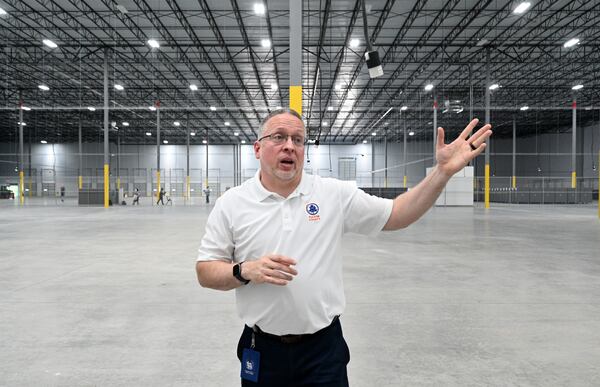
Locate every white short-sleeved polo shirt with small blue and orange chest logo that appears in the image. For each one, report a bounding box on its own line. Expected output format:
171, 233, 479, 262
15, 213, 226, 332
198, 171, 393, 335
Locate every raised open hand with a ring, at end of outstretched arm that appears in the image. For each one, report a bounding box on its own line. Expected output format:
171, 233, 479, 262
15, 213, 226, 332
436, 118, 492, 177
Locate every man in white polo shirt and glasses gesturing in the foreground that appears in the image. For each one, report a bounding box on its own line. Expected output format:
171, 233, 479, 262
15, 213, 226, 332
196, 110, 492, 387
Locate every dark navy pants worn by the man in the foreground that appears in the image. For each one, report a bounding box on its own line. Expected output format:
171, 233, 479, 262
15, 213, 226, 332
237, 320, 350, 387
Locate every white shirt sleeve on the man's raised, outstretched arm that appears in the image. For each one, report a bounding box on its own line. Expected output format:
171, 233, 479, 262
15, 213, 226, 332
340, 181, 394, 236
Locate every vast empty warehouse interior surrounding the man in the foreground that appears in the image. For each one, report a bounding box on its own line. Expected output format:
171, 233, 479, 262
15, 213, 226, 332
0, 0, 600, 387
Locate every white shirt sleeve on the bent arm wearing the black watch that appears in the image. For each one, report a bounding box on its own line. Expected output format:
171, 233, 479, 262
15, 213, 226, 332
197, 198, 234, 262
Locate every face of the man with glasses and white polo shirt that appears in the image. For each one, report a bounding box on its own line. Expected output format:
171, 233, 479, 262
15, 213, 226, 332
254, 113, 305, 183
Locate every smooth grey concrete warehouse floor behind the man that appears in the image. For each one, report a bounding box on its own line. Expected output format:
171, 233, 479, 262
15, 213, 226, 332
0, 201, 600, 387
